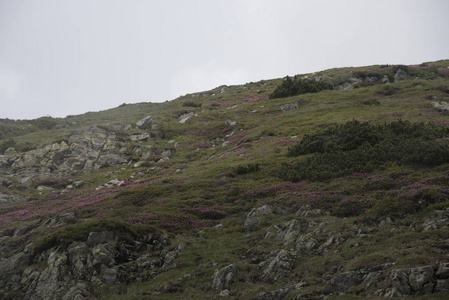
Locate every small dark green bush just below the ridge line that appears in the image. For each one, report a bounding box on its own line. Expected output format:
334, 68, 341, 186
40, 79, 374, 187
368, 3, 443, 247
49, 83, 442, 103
269, 76, 333, 99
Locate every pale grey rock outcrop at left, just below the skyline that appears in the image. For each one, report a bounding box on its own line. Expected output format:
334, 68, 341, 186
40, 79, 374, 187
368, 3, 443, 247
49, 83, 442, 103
0, 116, 162, 186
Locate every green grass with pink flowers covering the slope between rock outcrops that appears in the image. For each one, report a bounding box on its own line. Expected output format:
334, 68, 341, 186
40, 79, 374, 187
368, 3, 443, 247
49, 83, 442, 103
0, 60, 449, 299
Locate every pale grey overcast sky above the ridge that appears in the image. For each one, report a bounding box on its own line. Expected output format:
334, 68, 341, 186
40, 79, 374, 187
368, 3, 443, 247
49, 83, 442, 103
0, 0, 449, 119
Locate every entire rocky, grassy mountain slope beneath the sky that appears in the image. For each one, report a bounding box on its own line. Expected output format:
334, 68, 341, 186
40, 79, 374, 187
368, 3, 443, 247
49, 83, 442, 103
0, 60, 449, 299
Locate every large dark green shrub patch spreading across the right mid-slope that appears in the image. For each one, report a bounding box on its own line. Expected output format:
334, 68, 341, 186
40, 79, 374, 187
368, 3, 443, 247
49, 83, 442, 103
279, 120, 449, 182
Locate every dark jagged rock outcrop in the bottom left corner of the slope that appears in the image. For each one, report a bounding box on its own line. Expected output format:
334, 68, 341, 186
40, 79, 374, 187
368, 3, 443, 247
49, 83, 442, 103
0, 216, 185, 300
